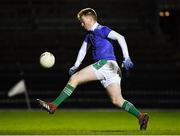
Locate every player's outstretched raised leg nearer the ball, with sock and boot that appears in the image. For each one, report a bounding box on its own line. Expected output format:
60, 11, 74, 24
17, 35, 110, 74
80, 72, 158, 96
37, 65, 98, 114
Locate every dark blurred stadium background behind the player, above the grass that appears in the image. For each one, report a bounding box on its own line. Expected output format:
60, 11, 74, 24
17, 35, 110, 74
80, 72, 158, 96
0, 0, 180, 109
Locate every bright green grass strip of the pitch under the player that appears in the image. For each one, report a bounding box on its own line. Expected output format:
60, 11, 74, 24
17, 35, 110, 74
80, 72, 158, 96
0, 110, 180, 135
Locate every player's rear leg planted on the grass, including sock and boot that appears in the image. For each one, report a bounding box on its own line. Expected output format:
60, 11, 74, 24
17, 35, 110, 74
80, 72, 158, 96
106, 83, 149, 130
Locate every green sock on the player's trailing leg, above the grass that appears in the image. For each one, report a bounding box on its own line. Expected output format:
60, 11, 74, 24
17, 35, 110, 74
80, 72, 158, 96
122, 101, 140, 118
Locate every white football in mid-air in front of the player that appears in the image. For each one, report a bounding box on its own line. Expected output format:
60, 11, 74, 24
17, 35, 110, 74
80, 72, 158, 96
40, 52, 55, 68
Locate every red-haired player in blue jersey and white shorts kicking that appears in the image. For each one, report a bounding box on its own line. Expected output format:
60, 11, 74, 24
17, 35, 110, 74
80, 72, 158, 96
37, 8, 149, 130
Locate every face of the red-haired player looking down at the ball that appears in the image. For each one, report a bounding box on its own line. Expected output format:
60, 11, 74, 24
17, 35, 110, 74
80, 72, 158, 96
80, 15, 94, 31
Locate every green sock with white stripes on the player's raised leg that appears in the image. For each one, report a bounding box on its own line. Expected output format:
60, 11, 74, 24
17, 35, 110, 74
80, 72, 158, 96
52, 84, 75, 106
